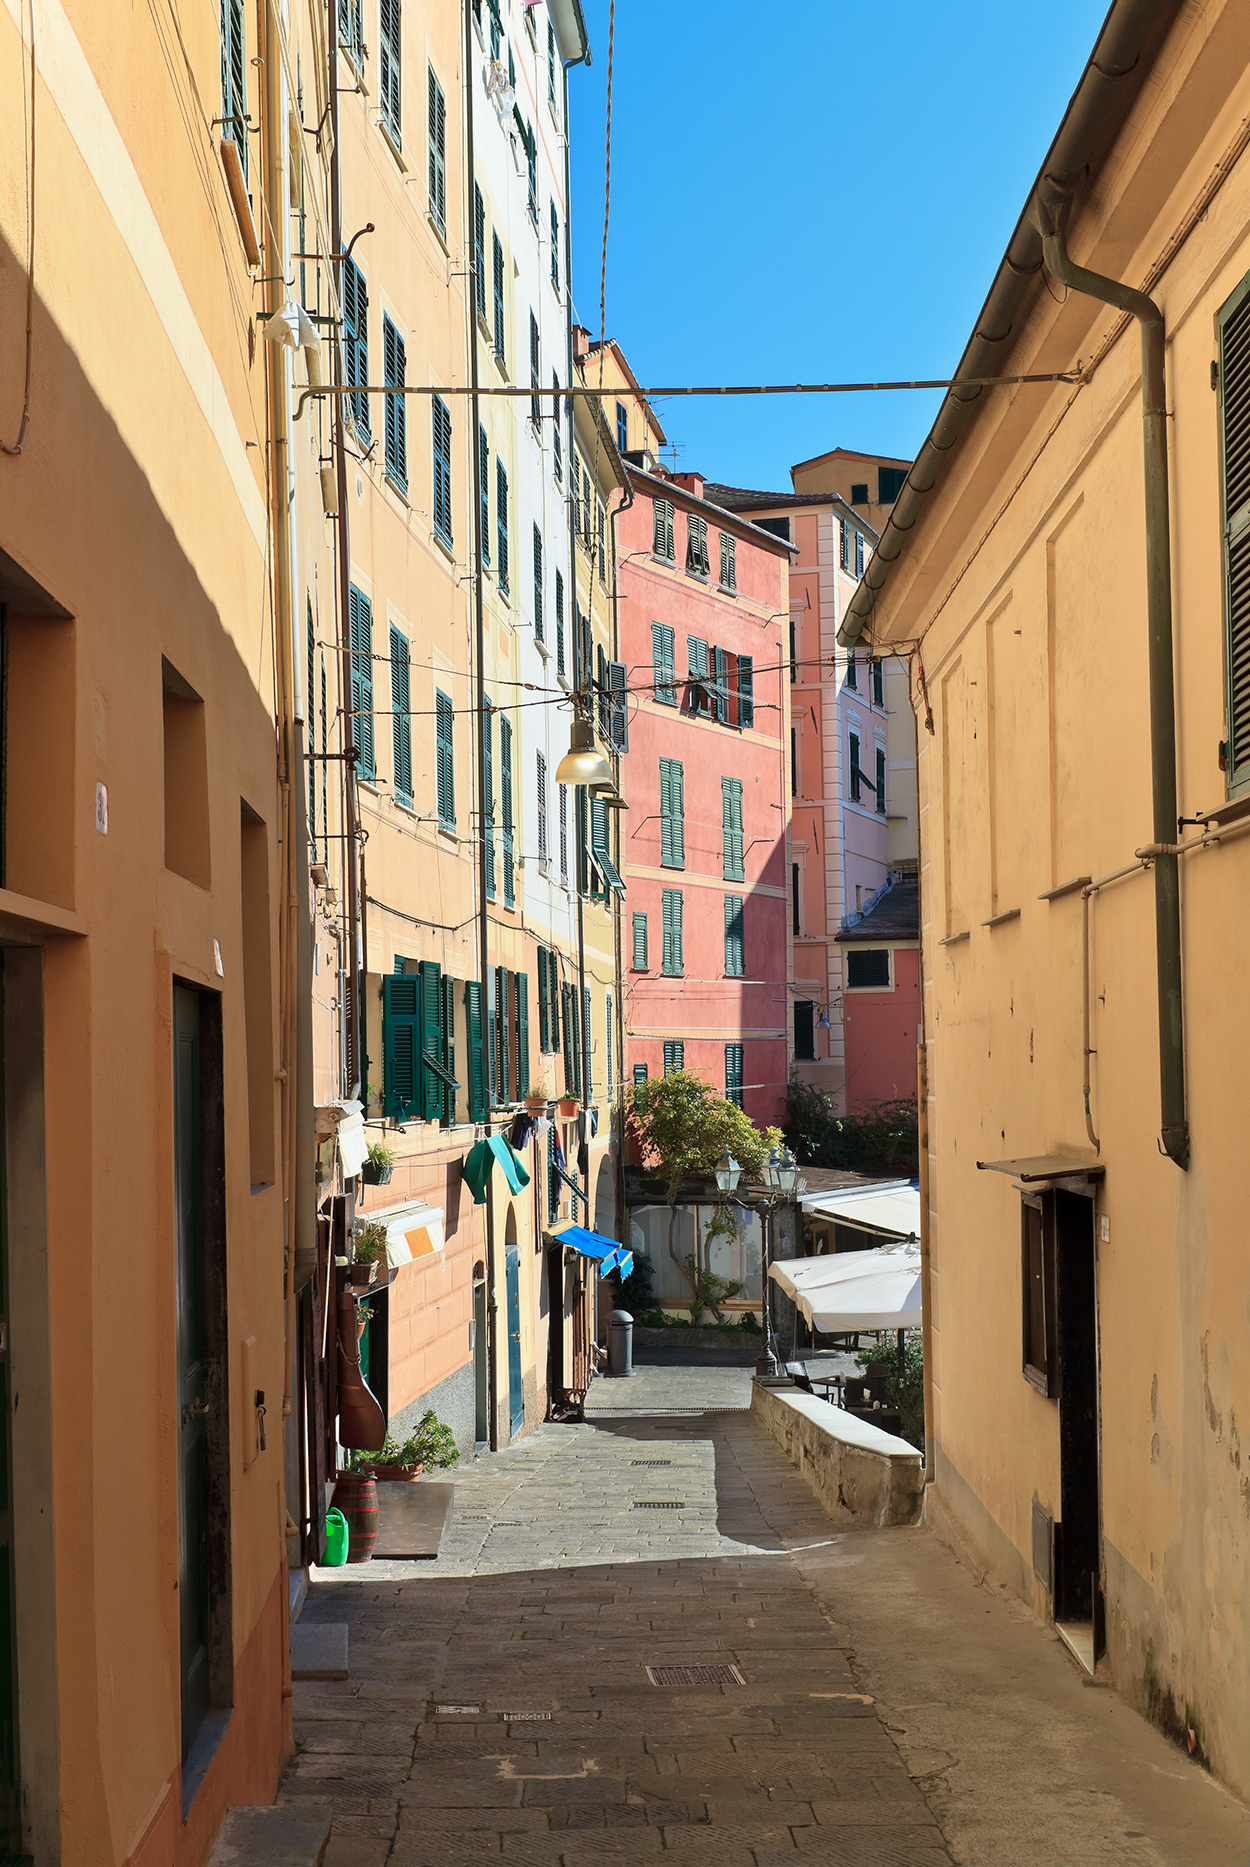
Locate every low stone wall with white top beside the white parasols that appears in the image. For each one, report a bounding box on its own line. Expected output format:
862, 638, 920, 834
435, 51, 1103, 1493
750, 1382, 924, 1529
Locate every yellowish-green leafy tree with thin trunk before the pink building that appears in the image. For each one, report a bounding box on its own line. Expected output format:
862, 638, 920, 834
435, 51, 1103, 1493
629, 1070, 782, 1301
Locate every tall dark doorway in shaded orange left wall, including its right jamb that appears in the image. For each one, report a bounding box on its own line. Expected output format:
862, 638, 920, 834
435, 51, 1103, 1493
174, 984, 233, 1787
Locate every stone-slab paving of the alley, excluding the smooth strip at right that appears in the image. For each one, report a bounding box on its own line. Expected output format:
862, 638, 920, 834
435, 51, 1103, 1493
280, 1369, 951, 1867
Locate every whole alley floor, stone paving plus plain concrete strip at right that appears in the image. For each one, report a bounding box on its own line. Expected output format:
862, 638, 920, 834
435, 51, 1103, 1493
278, 1367, 1244, 1867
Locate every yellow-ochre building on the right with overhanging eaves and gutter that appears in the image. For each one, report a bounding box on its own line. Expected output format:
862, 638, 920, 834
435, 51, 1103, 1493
840, 4, 1250, 1794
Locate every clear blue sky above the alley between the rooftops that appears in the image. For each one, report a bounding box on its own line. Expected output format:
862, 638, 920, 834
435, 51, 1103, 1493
569, 0, 1106, 487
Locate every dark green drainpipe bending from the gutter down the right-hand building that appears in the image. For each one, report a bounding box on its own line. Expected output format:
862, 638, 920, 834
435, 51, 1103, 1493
1035, 187, 1188, 1171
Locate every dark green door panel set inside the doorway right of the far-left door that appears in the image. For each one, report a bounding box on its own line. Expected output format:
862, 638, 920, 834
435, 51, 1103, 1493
174, 986, 209, 1762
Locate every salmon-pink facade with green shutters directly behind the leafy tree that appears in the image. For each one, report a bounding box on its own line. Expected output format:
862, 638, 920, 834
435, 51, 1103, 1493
616, 469, 791, 1126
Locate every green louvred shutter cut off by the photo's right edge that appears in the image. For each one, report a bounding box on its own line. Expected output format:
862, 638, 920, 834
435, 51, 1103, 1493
1218, 276, 1250, 797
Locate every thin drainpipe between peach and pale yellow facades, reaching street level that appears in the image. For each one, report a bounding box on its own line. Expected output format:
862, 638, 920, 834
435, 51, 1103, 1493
463, 0, 500, 1453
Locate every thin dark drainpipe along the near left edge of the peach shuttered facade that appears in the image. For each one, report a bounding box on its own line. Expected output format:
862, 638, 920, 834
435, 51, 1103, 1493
326, 6, 362, 1098
